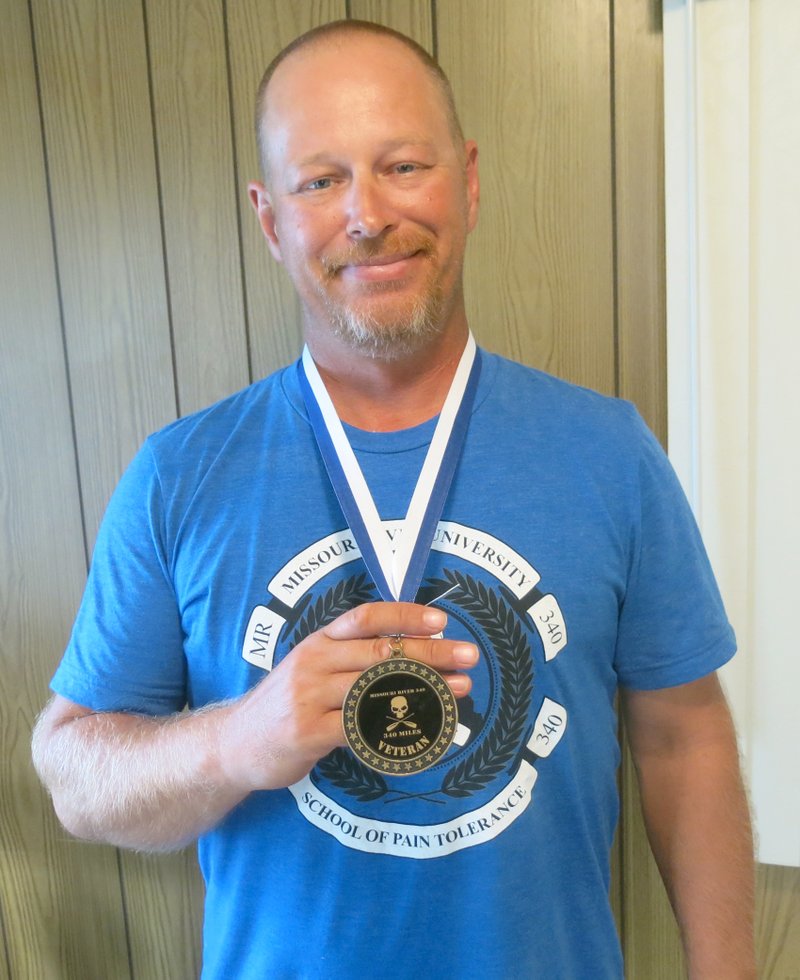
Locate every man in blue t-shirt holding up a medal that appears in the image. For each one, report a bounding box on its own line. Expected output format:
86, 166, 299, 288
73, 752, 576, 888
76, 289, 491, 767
34, 22, 754, 978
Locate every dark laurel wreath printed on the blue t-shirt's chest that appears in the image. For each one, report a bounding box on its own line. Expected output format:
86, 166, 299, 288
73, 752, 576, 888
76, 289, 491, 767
304, 571, 533, 802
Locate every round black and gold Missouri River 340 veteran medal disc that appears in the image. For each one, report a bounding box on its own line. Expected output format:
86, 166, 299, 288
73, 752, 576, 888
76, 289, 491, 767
343, 637, 458, 776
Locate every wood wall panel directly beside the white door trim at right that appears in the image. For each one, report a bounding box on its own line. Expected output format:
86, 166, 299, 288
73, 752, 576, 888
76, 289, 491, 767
612, 0, 685, 980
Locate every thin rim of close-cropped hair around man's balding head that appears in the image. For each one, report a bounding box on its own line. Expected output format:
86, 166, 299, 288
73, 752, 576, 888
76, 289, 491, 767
255, 20, 464, 181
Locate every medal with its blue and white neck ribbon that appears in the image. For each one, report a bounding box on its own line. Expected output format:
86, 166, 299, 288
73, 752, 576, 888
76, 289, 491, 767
299, 334, 480, 776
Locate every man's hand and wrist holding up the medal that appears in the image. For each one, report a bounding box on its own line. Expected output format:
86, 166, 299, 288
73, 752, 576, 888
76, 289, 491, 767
219, 602, 478, 793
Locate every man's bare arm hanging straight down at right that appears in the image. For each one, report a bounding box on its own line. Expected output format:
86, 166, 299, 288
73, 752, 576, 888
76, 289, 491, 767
622, 674, 756, 980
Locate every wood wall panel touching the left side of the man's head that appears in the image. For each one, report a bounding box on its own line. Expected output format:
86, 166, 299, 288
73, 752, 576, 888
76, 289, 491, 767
228, 0, 345, 378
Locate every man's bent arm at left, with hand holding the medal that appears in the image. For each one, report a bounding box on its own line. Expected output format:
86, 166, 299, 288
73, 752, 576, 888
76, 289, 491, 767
33, 602, 478, 850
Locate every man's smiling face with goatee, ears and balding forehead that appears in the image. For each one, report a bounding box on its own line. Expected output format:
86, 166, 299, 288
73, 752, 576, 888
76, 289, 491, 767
250, 34, 478, 372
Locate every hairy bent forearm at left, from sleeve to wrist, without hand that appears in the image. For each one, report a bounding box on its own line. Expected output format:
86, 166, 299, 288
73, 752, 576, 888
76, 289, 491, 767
33, 707, 245, 851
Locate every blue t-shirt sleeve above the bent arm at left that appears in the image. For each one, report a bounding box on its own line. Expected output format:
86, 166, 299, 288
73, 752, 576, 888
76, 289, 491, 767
50, 443, 186, 714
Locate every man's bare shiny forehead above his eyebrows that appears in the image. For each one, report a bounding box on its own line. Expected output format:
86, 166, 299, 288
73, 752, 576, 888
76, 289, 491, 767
264, 35, 450, 162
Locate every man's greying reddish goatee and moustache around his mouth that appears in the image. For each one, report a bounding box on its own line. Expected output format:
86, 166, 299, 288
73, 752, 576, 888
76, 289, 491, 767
320, 235, 445, 361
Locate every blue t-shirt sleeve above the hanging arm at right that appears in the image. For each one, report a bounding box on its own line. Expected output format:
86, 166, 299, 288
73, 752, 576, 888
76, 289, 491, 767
615, 413, 736, 690
